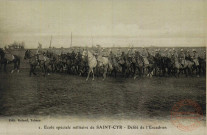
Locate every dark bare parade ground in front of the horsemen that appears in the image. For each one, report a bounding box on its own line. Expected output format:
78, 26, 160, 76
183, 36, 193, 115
0, 66, 206, 119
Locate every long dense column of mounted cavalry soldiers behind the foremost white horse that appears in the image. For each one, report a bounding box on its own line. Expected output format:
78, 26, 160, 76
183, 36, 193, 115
1, 46, 206, 78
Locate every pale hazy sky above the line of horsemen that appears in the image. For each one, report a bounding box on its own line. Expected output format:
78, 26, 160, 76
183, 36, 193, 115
0, 0, 207, 48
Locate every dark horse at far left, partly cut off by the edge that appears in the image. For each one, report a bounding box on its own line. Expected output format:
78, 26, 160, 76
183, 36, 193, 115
0, 49, 20, 73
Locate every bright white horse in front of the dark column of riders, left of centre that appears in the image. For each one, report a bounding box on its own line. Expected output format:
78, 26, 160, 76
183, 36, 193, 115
82, 51, 112, 81
